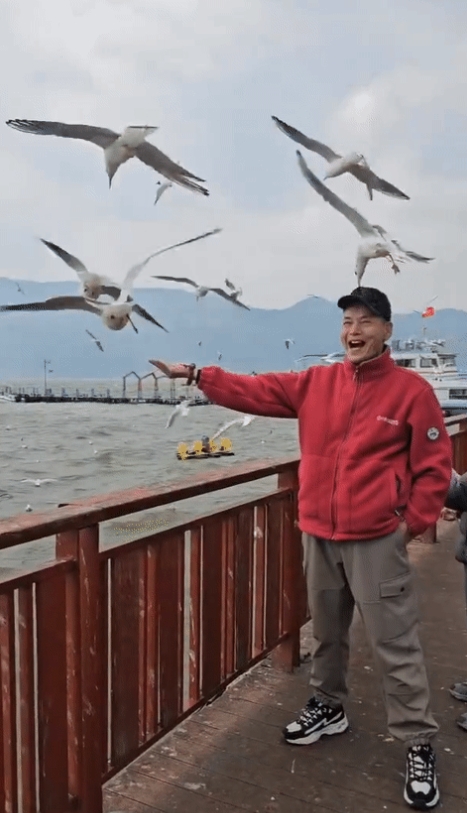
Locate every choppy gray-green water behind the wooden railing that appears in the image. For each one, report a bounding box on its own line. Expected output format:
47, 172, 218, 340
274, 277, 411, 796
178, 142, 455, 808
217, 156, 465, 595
0, 382, 298, 568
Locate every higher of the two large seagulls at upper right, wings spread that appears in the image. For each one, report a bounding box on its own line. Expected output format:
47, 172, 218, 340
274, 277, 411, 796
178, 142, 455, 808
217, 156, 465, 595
271, 116, 410, 200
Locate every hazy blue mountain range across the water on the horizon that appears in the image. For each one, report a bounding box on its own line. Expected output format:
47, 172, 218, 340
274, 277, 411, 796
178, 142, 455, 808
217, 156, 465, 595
0, 277, 467, 382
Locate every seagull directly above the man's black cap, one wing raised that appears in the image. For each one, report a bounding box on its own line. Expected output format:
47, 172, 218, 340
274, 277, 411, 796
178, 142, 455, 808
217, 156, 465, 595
297, 150, 434, 285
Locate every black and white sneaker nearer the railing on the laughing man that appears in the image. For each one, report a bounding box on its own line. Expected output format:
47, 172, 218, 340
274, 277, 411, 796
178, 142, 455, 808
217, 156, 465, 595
284, 697, 349, 745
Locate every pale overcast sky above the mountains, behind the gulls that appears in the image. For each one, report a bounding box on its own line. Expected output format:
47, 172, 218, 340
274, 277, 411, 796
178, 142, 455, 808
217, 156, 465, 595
0, 0, 467, 312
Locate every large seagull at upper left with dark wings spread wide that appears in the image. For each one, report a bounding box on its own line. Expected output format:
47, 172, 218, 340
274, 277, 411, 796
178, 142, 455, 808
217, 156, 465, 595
6, 119, 209, 195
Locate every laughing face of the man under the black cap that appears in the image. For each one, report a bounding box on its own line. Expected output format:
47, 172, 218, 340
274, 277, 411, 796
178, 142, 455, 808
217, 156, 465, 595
341, 305, 392, 364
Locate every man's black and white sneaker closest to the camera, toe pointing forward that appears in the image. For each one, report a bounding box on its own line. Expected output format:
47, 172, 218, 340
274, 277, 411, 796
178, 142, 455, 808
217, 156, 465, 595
404, 744, 439, 810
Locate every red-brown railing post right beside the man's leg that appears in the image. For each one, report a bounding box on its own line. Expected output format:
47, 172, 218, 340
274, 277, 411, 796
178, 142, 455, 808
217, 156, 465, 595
271, 465, 304, 672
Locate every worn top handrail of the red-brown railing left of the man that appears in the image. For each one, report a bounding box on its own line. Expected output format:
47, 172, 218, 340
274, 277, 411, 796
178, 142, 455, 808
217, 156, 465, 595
0, 455, 299, 550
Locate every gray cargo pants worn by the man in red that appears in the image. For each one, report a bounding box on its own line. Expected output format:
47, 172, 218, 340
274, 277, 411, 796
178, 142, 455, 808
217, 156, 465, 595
303, 530, 439, 745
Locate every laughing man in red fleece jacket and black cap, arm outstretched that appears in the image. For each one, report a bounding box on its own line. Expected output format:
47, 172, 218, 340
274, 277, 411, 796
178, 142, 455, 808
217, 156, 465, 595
153, 287, 451, 810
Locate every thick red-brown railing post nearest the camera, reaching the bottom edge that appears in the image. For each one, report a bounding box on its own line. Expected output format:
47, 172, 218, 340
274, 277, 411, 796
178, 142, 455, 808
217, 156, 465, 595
57, 525, 104, 813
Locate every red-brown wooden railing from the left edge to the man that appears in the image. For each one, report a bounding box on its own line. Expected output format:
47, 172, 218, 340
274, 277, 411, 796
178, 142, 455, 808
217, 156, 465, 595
0, 458, 306, 813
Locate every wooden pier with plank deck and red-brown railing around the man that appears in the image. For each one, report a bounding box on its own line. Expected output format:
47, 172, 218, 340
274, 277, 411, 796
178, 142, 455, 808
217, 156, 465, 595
0, 416, 467, 813
